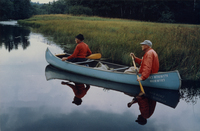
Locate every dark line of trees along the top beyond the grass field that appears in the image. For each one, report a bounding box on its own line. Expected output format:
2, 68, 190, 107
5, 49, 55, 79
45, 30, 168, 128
0, 0, 200, 24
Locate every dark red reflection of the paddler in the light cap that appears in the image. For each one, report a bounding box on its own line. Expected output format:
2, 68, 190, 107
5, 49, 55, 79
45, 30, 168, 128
127, 94, 156, 125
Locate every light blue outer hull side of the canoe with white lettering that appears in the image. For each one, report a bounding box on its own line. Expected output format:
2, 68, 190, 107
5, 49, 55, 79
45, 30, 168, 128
46, 48, 181, 90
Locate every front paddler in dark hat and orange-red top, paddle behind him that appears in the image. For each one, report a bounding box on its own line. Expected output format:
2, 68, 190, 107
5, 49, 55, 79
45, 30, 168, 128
62, 34, 92, 62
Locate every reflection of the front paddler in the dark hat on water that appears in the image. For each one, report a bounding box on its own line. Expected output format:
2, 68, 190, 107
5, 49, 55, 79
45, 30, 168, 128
61, 81, 90, 106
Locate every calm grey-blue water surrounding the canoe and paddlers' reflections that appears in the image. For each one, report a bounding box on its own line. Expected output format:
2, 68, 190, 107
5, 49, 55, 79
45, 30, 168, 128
0, 22, 200, 131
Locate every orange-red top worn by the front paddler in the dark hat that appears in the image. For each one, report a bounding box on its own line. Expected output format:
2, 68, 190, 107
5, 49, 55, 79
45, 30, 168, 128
68, 42, 92, 59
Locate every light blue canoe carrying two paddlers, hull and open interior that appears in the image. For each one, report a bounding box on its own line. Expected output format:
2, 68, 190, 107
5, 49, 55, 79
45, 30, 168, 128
45, 48, 181, 90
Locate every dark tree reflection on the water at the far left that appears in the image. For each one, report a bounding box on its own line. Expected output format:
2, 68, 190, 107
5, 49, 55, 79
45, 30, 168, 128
0, 23, 30, 52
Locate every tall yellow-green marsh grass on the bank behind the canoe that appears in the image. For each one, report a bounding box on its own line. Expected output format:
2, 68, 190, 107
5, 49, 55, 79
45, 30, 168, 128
18, 15, 200, 80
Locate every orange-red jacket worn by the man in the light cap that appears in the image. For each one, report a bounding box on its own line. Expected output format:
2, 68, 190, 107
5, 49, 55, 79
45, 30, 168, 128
135, 48, 159, 80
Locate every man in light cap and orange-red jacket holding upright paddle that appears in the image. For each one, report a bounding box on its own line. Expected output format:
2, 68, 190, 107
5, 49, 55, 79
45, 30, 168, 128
130, 40, 159, 81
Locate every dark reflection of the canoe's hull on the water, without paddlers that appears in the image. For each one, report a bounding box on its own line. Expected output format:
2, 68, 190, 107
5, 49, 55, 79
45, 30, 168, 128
45, 65, 180, 108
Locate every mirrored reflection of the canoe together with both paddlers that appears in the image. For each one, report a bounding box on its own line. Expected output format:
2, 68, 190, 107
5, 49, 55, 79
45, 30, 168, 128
45, 65, 179, 125
